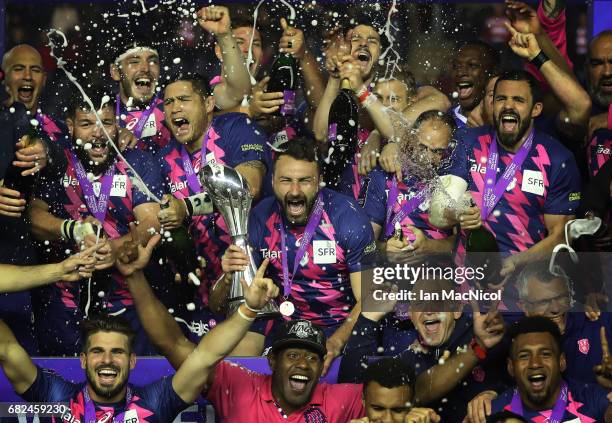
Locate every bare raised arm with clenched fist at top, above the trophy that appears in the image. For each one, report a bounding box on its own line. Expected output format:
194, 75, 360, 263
198, 6, 251, 110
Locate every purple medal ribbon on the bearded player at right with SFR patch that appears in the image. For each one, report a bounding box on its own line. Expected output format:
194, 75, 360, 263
481, 129, 534, 221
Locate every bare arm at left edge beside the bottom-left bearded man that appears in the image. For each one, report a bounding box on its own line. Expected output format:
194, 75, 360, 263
0, 320, 38, 395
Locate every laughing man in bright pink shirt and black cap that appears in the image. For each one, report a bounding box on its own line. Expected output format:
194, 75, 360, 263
120, 237, 365, 423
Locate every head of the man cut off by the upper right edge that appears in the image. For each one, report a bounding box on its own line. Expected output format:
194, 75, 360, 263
587, 30, 612, 108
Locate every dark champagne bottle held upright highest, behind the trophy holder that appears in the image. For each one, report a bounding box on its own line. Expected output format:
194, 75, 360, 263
267, 35, 299, 116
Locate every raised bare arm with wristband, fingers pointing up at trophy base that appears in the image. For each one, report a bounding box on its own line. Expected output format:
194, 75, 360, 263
172, 259, 278, 402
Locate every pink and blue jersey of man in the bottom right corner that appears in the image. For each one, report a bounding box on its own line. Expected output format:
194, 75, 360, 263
491, 380, 609, 423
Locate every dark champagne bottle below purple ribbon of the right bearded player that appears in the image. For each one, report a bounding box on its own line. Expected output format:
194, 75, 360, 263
465, 225, 502, 288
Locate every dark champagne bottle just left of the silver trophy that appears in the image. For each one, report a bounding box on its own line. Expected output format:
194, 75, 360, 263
161, 202, 200, 309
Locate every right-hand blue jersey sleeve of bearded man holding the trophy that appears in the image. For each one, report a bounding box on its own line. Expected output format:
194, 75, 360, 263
338, 200, 376, 273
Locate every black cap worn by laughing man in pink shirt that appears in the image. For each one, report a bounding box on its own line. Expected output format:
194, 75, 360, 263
272, 320, 327, 357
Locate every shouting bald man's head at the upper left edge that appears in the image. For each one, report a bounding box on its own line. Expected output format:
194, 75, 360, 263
2, 44, 46, 111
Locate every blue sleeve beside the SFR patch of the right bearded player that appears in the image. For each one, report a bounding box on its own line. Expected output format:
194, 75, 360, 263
544, 151, 581, 215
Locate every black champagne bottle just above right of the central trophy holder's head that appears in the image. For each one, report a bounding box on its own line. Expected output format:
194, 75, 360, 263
323, 79, 359, 188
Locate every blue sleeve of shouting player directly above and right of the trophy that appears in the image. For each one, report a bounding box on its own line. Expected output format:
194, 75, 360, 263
223, 114, 270, 169
